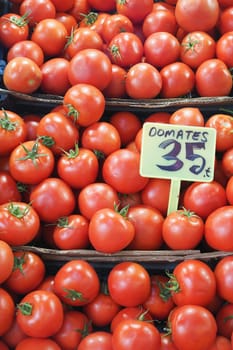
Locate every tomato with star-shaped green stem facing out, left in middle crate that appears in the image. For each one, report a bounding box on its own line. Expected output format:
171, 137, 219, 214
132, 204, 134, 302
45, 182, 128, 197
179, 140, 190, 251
9, 141, 55, 185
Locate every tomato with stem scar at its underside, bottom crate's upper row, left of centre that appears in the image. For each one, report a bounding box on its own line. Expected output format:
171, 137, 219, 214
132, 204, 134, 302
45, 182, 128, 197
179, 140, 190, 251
54, 259, 100, 306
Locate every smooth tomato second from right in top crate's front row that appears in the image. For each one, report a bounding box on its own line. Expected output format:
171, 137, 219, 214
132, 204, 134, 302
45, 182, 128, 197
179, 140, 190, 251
160, 62, 195, 98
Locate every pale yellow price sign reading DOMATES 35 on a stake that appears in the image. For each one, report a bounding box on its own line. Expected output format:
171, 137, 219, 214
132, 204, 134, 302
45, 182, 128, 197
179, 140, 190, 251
140, 122, 216, 212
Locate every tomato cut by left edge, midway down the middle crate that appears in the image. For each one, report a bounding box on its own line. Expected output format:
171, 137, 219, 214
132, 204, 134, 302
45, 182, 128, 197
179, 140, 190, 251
0, 171, 21, 204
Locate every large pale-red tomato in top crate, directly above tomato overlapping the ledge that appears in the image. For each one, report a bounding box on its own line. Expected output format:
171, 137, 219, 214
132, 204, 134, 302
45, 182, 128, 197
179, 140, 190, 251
68, 48, 112, 91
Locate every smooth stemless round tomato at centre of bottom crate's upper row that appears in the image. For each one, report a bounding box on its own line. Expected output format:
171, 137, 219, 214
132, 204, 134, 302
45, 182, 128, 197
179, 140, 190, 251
107, 261, 151, 307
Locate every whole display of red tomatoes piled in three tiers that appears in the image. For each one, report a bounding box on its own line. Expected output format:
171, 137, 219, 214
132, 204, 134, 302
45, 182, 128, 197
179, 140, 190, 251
0, 0, 233, 350
